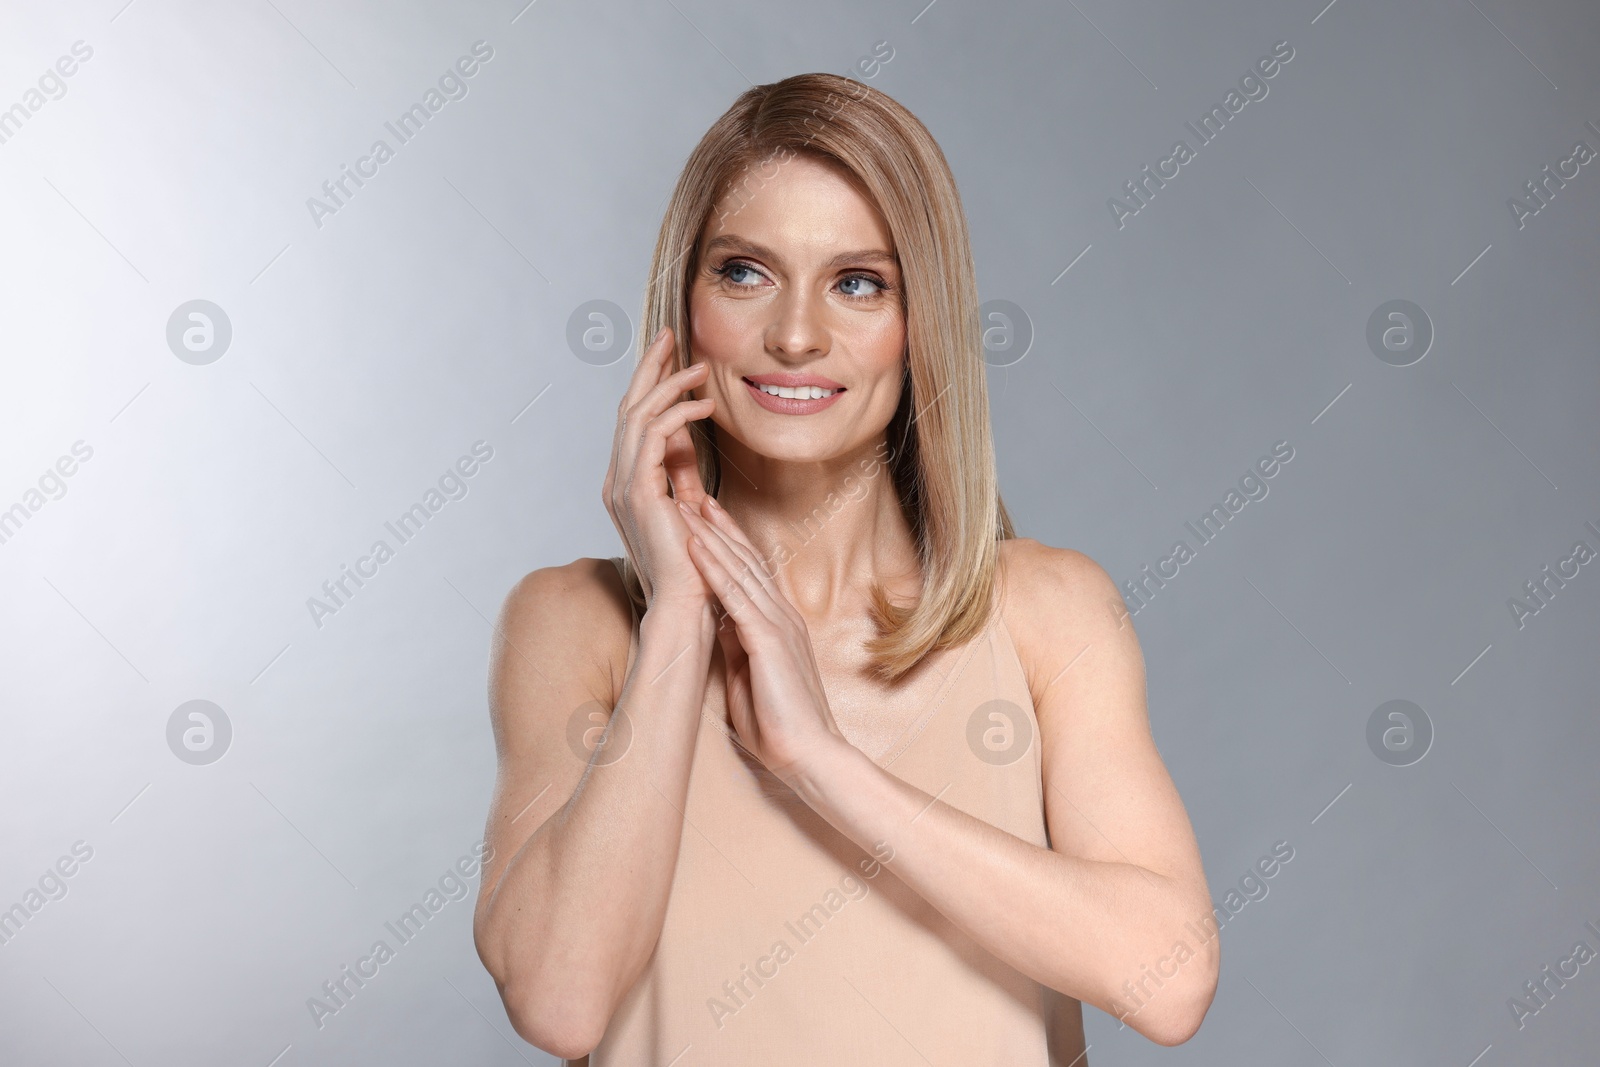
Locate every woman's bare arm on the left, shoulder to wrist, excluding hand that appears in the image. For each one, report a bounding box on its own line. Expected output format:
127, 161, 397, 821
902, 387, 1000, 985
474, 560, 715, 1059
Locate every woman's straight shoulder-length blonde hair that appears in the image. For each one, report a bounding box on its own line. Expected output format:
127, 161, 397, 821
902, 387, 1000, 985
624, 74, 1016, 681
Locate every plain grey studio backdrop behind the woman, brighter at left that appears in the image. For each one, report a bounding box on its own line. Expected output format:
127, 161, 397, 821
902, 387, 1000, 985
0, 0, 1600, 1067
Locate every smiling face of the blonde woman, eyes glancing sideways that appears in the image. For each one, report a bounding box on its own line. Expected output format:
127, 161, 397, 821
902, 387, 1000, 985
690, 155, 906, 462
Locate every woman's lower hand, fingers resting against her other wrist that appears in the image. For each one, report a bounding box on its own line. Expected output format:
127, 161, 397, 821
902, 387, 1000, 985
680, 496, 848, 784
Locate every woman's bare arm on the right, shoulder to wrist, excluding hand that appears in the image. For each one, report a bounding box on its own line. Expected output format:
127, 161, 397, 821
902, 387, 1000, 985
792, 541, 1221, 1045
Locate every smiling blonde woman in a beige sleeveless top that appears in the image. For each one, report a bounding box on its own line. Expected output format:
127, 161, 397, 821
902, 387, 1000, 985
474, 74, 1219, 1067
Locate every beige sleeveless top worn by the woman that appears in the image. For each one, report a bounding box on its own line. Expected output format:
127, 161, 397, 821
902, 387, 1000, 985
595, 558, 1088, 1067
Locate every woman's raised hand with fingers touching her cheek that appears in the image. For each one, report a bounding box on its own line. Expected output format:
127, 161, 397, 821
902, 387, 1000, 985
600, 330, 715, 608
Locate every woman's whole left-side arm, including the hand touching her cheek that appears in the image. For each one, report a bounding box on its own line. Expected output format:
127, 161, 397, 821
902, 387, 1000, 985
472, 328, 715, 1059
